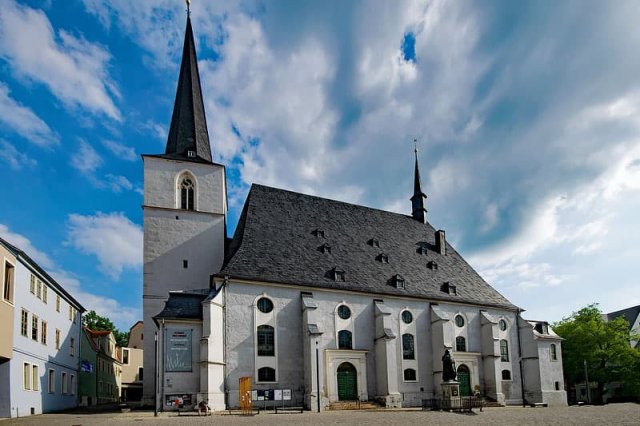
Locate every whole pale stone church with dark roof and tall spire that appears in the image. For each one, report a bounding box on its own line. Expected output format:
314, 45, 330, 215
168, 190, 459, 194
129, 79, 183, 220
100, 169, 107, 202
143, 17, 566, 410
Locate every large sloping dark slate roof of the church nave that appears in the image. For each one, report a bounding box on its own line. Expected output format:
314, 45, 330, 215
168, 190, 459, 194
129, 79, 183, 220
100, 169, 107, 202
218, 184, 516, 309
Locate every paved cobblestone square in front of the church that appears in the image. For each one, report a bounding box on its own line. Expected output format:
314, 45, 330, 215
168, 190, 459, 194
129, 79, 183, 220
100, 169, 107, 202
0, 404, 640, 426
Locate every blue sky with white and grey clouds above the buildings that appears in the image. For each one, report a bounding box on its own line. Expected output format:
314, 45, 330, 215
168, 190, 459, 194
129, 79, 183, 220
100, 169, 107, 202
0, 0, 640, 330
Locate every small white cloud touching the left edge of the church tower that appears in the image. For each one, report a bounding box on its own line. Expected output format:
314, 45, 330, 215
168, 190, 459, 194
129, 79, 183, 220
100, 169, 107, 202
67, 212, 142, 279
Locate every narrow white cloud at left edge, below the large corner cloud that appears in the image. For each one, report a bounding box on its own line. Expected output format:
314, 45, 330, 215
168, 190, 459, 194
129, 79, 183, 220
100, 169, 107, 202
0, 82, 60, 147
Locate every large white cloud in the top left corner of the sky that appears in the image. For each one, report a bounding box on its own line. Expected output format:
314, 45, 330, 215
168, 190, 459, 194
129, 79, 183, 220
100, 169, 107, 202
0, 0, 122, 121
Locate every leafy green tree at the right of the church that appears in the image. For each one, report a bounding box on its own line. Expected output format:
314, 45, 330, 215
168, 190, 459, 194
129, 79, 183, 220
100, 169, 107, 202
553, 304, 640, 402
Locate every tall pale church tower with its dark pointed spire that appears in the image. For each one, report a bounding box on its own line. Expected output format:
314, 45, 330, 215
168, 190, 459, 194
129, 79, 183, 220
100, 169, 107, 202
142, 15, 227, 404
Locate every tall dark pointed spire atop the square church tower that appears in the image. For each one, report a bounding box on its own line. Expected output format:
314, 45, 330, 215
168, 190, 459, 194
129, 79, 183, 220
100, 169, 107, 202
165, 10, 211, 161
